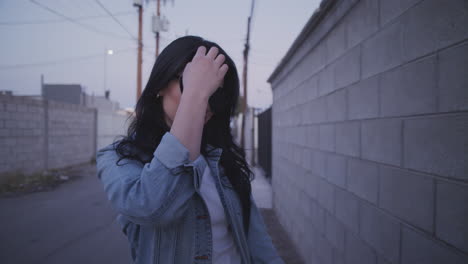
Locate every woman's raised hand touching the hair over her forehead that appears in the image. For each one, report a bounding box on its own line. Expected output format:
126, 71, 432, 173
182, 46, 228, 100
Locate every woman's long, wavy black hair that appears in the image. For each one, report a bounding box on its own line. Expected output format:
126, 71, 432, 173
114, 36, 254, 233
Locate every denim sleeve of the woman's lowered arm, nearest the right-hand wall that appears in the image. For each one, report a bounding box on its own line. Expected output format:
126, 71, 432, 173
247, 195, 284, 264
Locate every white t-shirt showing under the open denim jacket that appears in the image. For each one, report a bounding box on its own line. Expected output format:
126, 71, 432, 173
200, 157, 241, 264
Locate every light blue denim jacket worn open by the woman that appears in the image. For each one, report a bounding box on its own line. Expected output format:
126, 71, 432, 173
96, 132, 284, 264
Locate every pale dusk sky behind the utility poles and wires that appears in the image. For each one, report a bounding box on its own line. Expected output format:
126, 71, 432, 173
0, 0, 320, 108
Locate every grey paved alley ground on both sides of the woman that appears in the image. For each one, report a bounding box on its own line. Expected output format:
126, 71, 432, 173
0, 162, 302, 264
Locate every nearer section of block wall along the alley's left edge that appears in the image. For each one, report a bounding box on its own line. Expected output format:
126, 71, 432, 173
0, 95, 96, 173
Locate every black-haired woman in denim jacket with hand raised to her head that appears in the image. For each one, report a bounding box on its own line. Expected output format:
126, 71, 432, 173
96, 36, 283, 264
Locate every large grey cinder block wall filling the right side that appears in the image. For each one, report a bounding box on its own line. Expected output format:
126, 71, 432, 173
270, 0, 468, 264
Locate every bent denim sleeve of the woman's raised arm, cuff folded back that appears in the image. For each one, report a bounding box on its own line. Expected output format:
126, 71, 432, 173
96, 132, 207, 226
